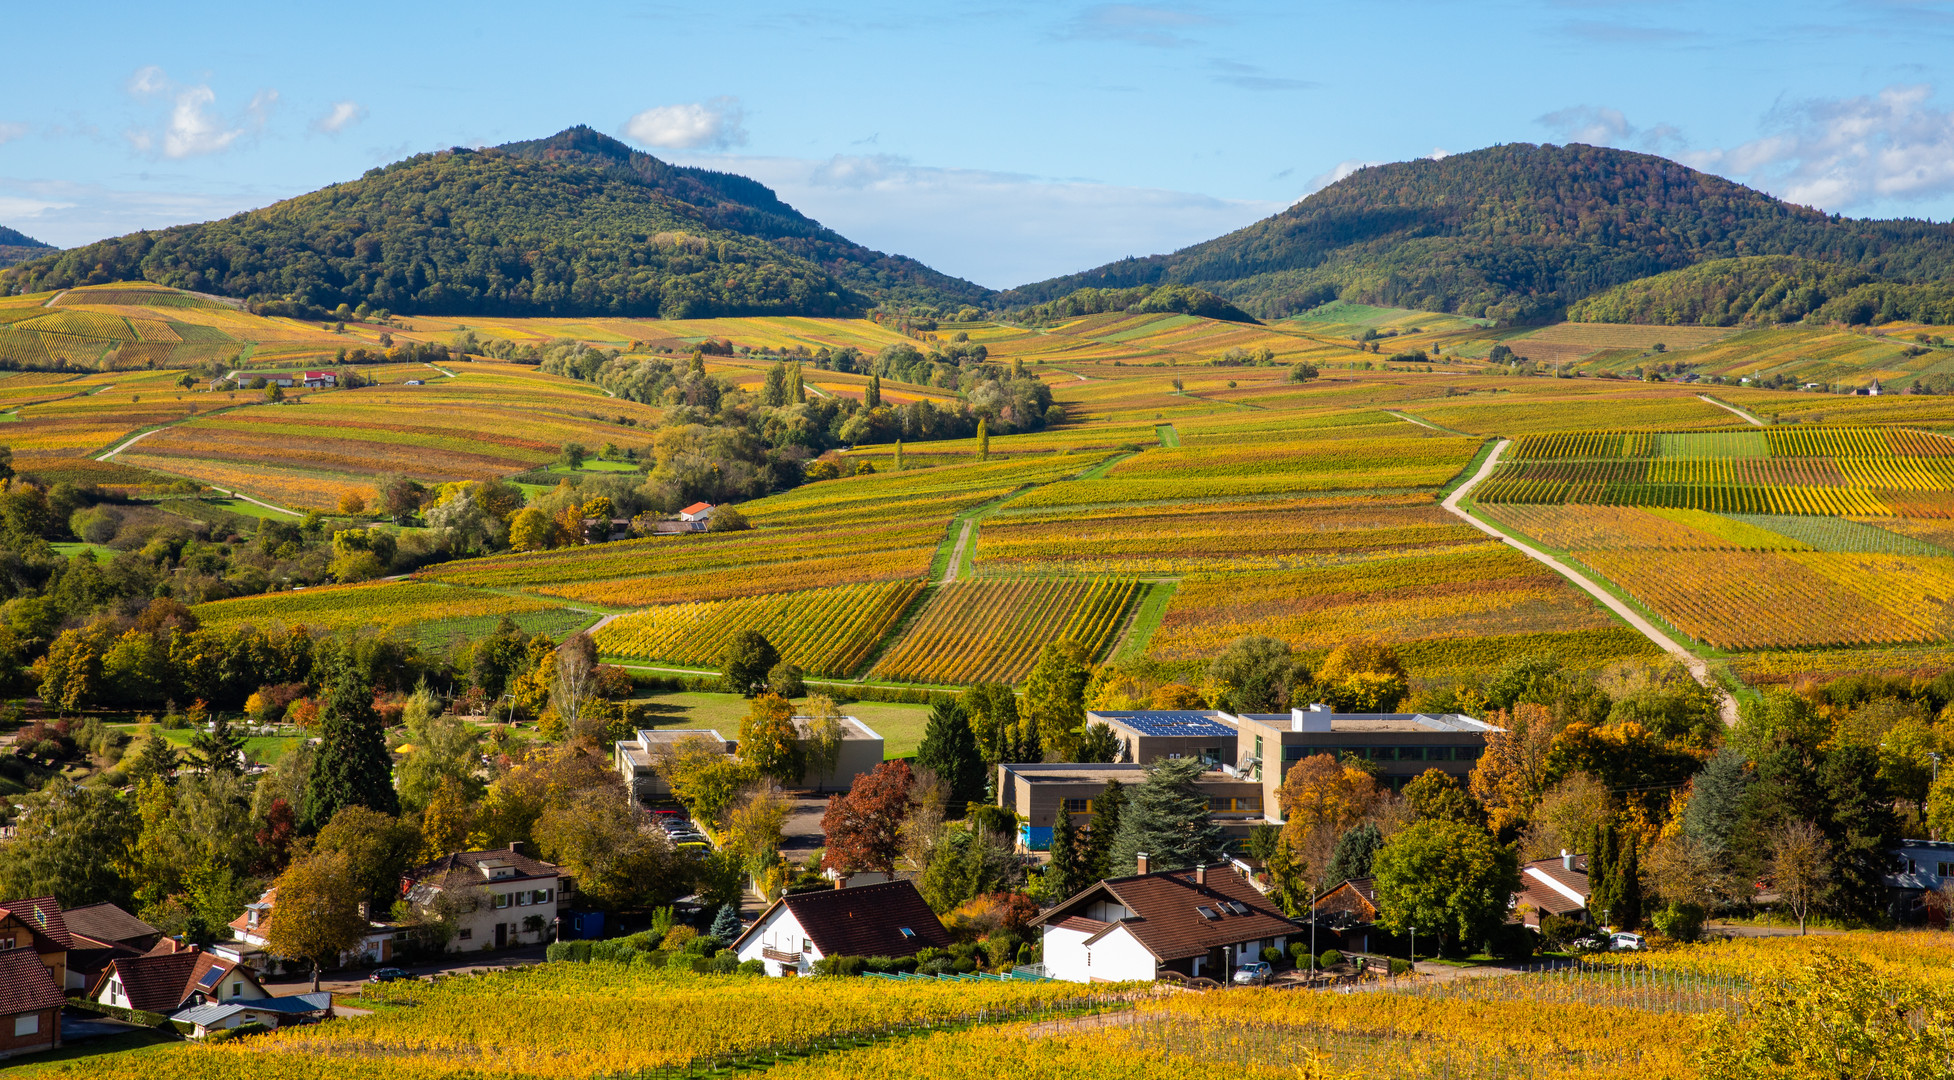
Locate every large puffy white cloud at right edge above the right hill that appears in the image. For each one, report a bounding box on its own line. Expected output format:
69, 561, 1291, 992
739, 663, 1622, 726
1684, 86, 1954, 211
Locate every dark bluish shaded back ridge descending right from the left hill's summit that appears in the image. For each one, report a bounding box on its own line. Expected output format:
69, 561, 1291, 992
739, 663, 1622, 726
496, 125, 995, 309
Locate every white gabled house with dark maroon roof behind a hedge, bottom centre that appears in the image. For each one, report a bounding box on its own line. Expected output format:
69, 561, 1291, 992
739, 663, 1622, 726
729, 879, 950, 975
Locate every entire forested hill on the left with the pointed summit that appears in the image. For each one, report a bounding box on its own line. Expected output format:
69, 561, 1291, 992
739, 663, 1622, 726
0, 129, 985, 318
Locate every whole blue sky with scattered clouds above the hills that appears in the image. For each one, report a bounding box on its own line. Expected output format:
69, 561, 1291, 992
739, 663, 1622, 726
0, 0, 1954, 287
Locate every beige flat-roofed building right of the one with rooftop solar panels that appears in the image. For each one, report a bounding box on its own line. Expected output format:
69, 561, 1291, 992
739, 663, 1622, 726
1235, 705, 1499, 804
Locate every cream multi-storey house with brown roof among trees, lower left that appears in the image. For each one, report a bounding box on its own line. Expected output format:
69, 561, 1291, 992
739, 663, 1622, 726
401, 842, 576, 953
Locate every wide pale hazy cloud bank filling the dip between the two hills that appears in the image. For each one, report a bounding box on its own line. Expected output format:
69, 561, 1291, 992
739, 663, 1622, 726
664, 154, 1282, 289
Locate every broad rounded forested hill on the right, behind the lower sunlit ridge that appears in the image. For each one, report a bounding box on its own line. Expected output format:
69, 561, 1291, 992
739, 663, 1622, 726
998, 143, 1954, 320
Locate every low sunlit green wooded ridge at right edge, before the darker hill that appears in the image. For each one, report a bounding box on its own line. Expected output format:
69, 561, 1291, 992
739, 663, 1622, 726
1567, 256, 1954, 326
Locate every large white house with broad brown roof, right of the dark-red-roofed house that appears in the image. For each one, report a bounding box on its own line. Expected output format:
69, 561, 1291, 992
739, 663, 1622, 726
1032, 855, 1297, 982
